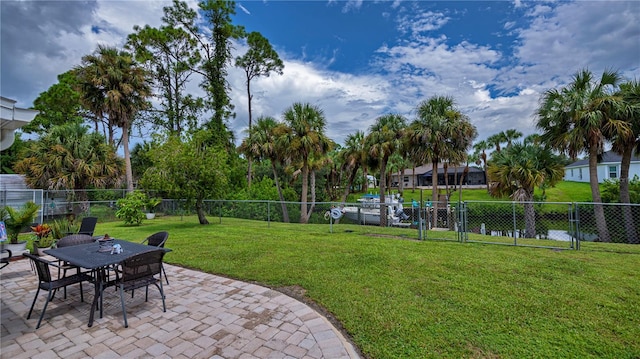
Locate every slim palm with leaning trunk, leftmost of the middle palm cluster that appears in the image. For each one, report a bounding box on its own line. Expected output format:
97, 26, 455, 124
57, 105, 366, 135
239, 117, 289, 223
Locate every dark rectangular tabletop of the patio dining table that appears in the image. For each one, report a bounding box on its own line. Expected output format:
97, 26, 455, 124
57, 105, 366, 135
44, 239, 171, 269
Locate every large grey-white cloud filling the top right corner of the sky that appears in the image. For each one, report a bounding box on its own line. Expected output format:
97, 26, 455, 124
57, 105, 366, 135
515, 1, 640, 83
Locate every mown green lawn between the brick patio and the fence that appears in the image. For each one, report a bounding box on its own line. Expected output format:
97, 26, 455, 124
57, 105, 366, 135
95, 216, 640, 358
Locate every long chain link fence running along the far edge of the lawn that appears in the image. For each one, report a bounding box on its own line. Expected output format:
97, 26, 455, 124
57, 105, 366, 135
0, 190, 640, 249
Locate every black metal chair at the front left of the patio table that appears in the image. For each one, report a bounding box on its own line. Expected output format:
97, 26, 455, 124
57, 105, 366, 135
24, 253, 92, 329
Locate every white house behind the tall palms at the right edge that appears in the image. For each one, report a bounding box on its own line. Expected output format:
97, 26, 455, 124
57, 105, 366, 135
564, 151, 640, 183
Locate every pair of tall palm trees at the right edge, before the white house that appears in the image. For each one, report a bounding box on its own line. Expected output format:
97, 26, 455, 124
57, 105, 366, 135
537, 69, 640, 243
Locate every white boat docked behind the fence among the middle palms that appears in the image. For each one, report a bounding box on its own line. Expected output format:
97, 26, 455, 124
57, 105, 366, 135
342, 194, 409, 226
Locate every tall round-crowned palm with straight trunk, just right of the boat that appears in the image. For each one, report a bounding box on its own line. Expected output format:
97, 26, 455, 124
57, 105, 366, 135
408, 96, 477, 226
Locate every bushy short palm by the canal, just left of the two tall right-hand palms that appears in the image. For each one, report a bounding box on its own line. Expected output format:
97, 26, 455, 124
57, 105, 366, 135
488, 143, 564, 238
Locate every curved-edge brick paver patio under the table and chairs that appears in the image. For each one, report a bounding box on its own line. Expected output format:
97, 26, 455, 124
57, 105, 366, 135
0, 259, 358, 359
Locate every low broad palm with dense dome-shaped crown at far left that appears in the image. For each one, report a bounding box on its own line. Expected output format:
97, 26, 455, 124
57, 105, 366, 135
15, 123, 123, 208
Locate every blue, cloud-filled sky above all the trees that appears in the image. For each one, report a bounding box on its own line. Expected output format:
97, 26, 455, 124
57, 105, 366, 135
0, 0, 640, 149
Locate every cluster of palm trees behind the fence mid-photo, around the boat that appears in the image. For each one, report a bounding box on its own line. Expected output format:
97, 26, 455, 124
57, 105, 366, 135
240, 96, 477, 224
